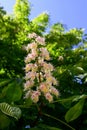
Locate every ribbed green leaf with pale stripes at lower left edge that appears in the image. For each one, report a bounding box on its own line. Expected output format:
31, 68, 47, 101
0, 103, 21, 120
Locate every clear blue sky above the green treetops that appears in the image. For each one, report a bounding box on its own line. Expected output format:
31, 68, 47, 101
0, 0, 87, 30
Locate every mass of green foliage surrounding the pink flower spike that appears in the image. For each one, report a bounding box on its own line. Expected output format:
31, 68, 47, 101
0, 0, 87, 130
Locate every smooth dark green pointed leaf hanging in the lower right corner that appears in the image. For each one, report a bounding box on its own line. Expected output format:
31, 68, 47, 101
65, 99, 85, 122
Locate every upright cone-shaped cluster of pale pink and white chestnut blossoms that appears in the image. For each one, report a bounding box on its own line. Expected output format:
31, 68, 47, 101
24, 33, 59, 103
